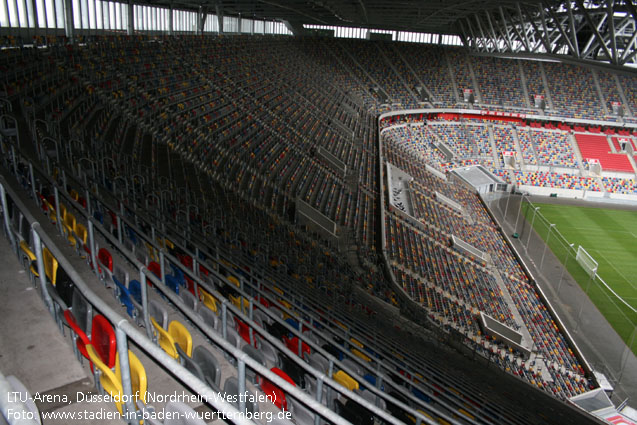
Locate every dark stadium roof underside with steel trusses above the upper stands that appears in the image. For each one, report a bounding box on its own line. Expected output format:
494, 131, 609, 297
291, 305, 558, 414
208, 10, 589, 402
152, 0, 637, 66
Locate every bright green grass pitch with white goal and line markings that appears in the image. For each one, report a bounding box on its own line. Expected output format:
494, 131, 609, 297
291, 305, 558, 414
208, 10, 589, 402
525, 200, 637, 354
